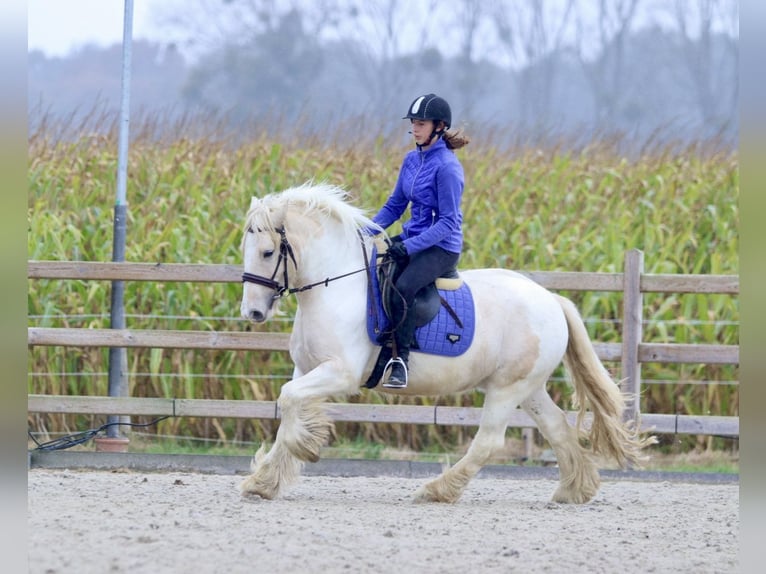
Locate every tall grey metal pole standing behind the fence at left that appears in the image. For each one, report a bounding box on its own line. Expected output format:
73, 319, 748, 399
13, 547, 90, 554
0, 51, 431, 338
107, 0, 133, 438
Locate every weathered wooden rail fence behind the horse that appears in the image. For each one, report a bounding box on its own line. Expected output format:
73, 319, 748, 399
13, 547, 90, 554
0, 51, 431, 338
27, 250, 739, 437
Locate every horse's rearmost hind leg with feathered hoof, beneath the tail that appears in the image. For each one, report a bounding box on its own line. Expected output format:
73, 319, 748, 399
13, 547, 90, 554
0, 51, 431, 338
521, 389, 601, 504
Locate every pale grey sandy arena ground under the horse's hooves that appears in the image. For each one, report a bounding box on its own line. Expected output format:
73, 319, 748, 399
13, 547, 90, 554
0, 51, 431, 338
28, 469, 739, 574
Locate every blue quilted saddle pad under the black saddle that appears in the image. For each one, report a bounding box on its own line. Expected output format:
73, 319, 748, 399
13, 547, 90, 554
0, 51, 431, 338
367, 249, 476, 357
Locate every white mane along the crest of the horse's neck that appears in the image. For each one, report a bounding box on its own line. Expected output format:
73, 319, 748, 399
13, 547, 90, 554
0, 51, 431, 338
245, 181, 379, 241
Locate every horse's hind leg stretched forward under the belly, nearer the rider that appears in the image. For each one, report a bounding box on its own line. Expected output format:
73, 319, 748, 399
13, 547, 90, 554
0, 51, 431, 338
415, 387, 519, 502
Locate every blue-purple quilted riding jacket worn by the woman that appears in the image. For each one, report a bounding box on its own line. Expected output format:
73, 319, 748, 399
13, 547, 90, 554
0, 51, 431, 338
372, 138, 464, 255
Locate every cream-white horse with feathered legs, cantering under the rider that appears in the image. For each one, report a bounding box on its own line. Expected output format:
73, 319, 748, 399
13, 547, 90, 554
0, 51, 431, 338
240, 181, 655, 504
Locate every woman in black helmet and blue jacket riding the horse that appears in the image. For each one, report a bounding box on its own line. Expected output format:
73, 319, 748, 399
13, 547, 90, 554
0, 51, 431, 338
373, 94, 470, 389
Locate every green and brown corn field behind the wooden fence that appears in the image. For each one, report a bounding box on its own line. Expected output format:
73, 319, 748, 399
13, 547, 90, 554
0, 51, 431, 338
28, 111, 739, 451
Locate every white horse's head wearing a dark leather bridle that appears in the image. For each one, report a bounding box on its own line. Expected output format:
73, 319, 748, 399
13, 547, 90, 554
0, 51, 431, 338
240, 197, 295, 323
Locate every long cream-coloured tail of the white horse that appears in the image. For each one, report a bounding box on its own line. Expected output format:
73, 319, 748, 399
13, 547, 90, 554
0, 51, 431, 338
556, 295, 657, 468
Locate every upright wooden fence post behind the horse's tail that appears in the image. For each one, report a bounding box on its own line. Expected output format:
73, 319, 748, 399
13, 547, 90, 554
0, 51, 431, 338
620, 249, 644, 422
